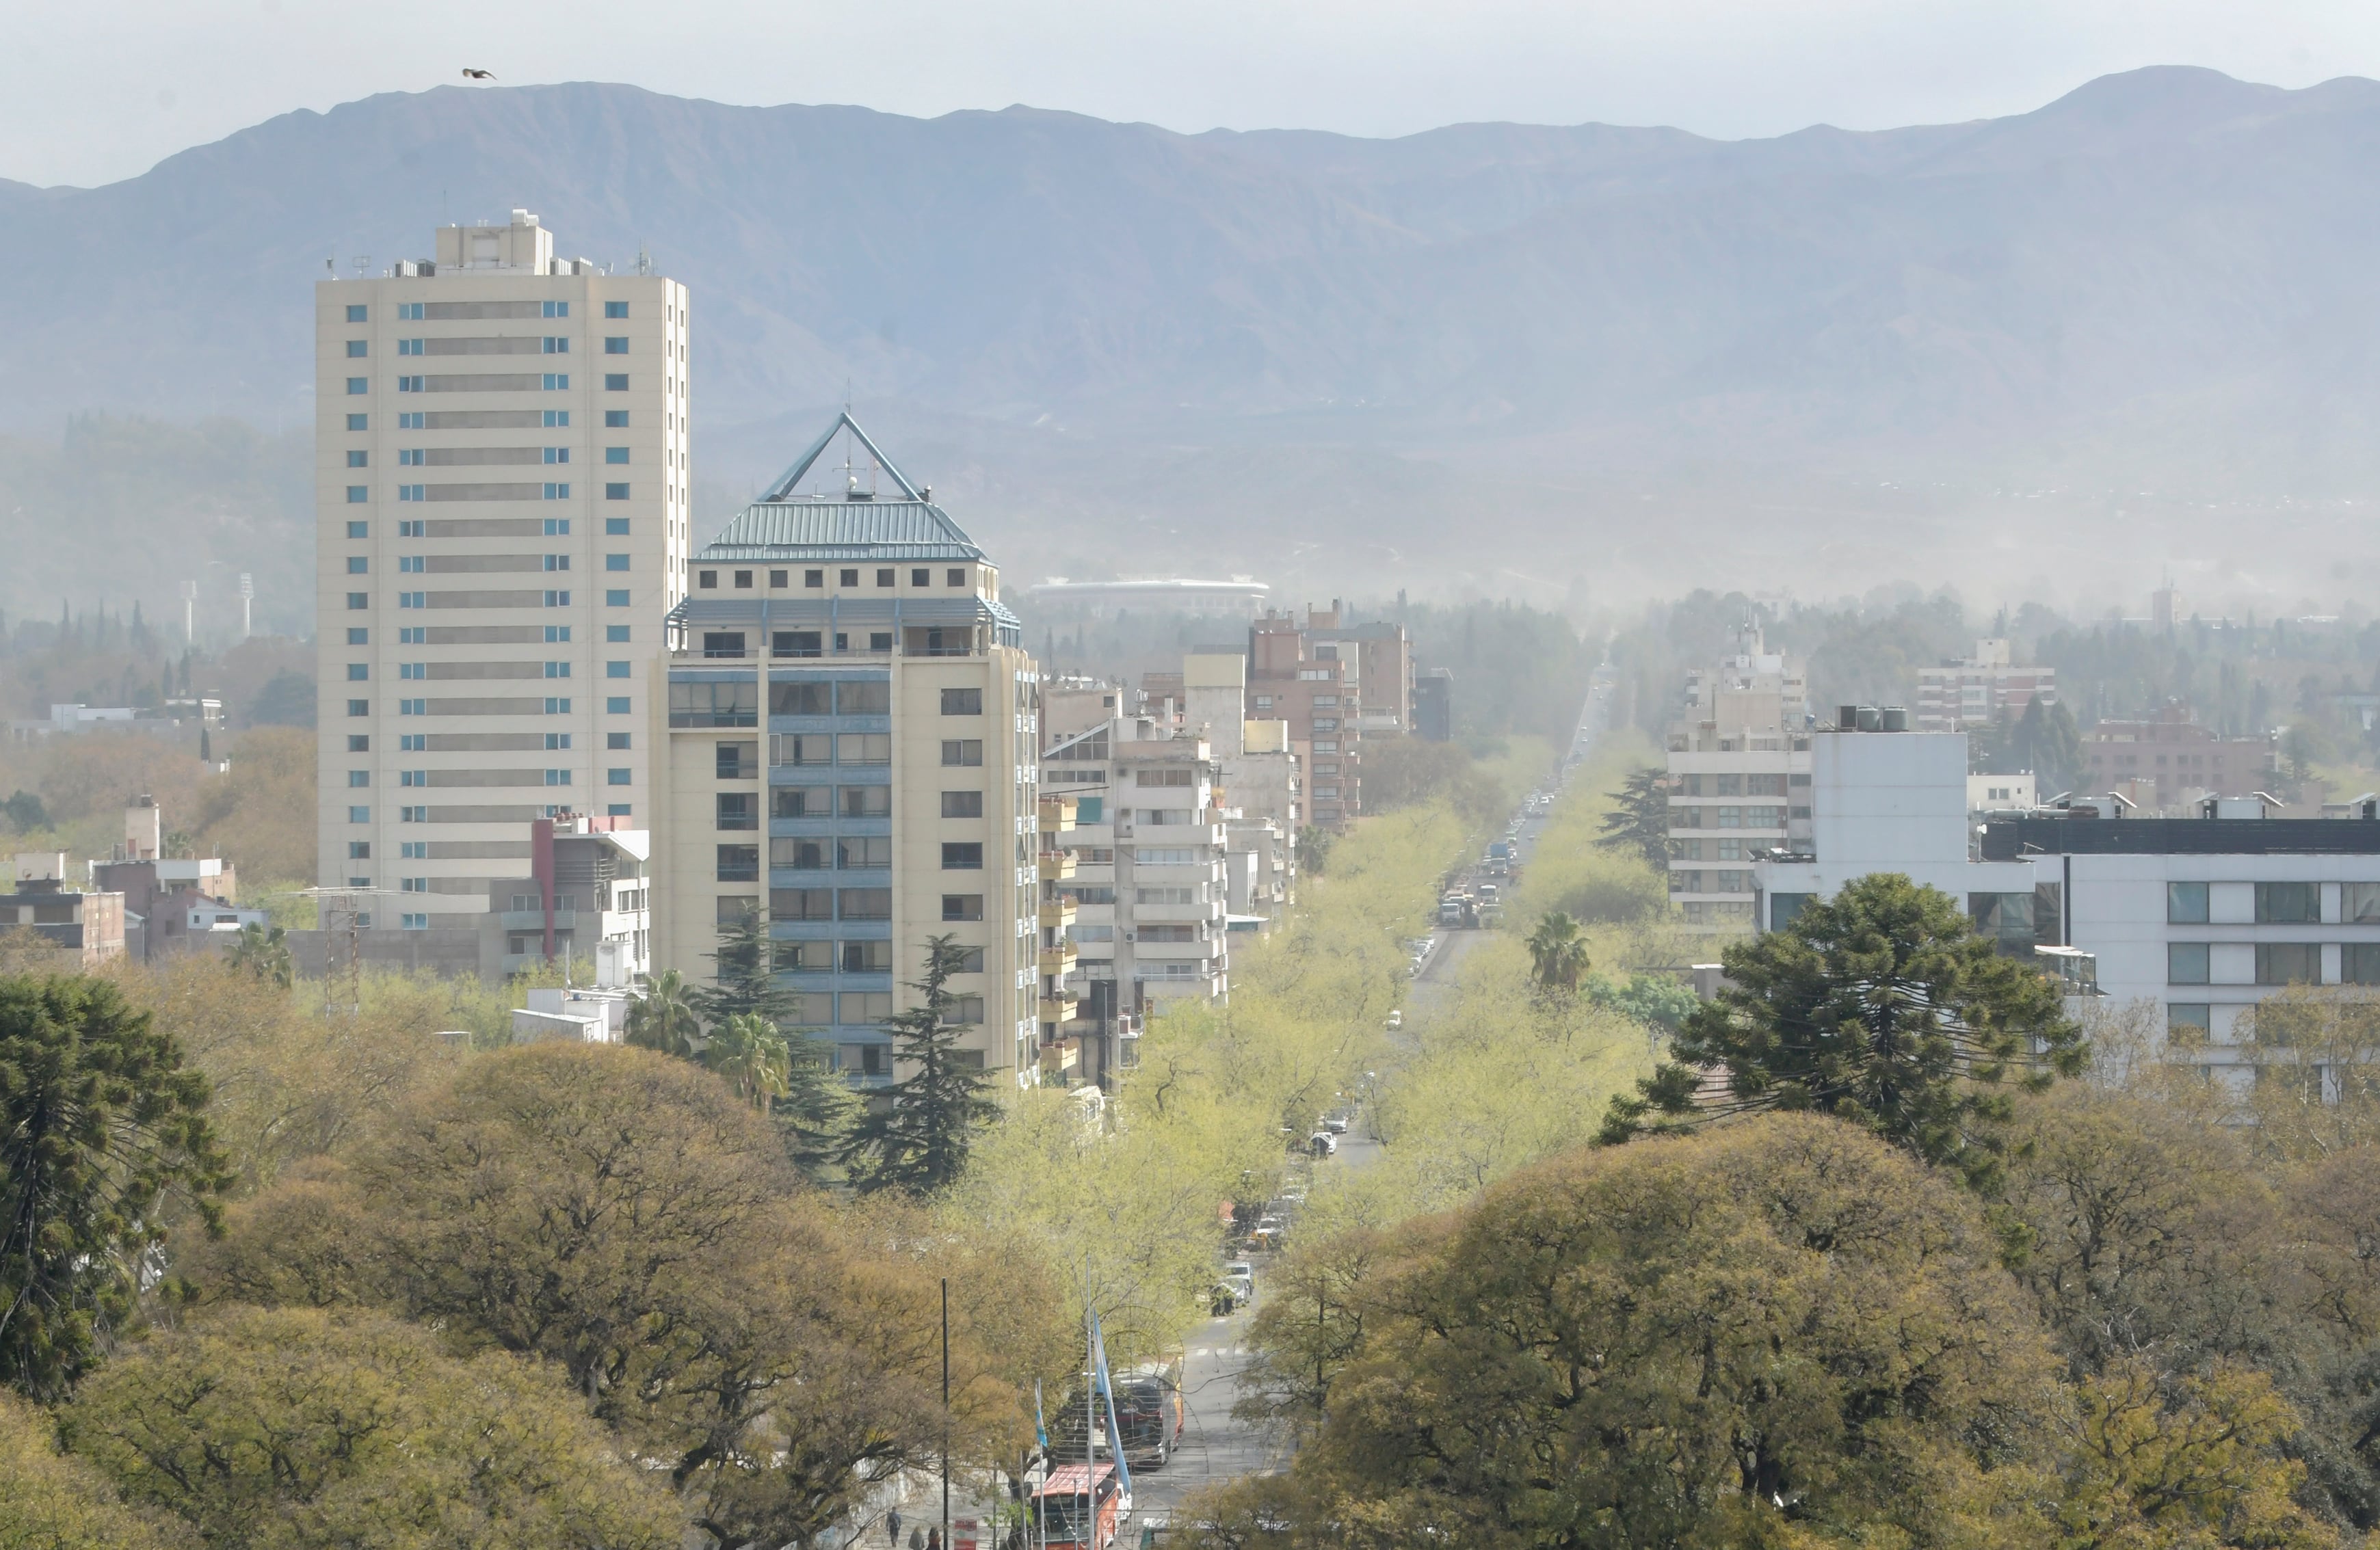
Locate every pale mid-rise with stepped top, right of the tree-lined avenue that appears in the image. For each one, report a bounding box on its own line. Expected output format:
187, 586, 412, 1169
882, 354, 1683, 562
1668, 624, 1811, 933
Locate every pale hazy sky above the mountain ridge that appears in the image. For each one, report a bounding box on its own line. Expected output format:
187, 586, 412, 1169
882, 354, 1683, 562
0, 0, 2380, 183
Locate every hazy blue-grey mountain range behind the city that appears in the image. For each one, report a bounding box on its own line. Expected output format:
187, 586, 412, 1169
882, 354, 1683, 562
0, 69, 2380, 600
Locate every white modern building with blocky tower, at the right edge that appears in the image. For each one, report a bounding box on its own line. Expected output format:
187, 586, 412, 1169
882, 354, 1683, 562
1754, 726, 2380, 1081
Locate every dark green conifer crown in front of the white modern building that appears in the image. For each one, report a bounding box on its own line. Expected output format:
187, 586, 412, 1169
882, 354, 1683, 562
1602, 872, 2085, 1188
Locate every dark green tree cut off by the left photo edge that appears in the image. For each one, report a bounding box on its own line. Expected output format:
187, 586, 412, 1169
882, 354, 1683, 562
0, 976, 226, 1398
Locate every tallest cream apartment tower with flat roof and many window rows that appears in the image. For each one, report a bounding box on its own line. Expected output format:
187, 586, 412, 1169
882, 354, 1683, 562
314, 209, 690, 928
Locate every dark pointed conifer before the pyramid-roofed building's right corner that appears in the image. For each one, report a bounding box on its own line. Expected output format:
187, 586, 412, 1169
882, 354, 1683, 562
843, 933, 1000, 1195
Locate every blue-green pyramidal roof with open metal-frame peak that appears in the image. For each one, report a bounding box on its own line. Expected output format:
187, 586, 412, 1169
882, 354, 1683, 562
698, 410, 983, 559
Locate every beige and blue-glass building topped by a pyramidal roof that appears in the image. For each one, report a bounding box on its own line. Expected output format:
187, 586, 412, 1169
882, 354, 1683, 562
643, 414, 1042, 1088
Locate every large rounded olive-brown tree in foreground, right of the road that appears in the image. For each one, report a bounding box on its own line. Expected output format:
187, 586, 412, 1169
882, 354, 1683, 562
1192, 1114, 2063, 1550
